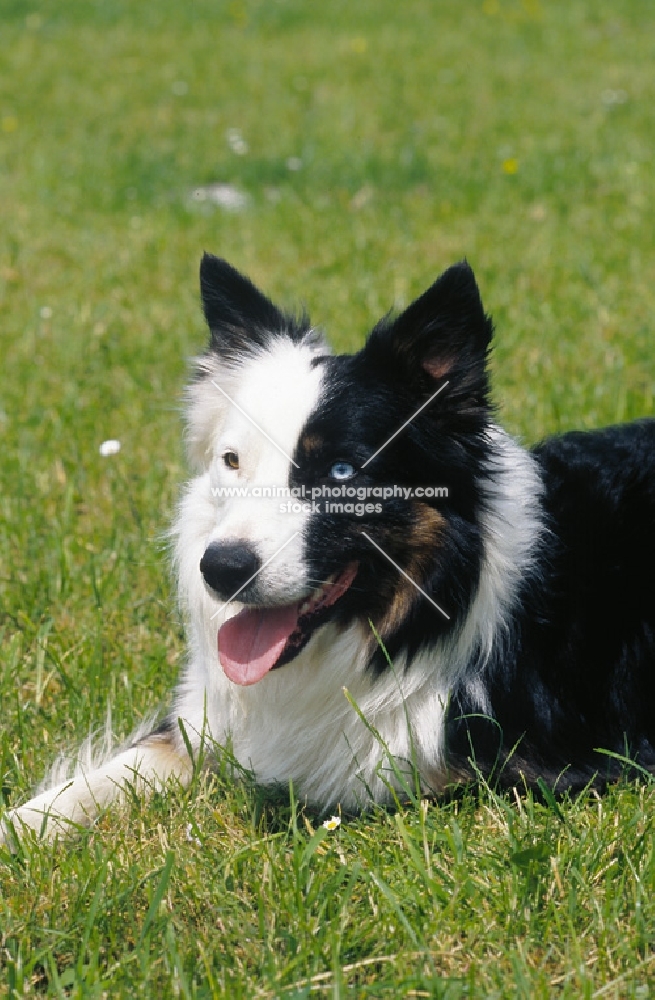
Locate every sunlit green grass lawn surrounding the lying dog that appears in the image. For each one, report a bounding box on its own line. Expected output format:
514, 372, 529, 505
0, 0, 655, 1000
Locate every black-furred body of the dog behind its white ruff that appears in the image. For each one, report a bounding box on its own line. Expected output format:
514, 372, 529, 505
450, 420, 655, 789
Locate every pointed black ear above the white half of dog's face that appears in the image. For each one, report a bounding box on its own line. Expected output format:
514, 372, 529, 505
200, 253, 290, 355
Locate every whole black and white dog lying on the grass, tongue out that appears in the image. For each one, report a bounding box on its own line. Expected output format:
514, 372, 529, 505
6, 255, 655, 836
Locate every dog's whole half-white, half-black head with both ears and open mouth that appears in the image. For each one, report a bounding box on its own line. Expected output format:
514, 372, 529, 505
184, 255, 491, 684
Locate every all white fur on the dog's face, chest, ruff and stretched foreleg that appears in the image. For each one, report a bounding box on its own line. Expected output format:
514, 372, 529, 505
5, 338, 542, 836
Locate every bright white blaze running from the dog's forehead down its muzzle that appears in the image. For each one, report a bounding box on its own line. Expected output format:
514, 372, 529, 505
207, 337, 323, 604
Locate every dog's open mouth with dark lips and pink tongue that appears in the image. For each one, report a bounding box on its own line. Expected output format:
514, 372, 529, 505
218, 563, 358, 685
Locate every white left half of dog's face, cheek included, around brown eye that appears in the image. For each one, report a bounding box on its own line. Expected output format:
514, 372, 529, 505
184, 335, 325, 600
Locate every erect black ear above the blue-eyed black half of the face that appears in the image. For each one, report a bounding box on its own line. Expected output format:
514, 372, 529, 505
367, 261, 492, 390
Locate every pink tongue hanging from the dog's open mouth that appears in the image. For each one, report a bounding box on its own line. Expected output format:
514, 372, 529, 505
218, 604, 300, 684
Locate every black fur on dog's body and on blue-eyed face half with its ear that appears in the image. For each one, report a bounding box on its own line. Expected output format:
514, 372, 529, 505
292, 264, 655, 789
